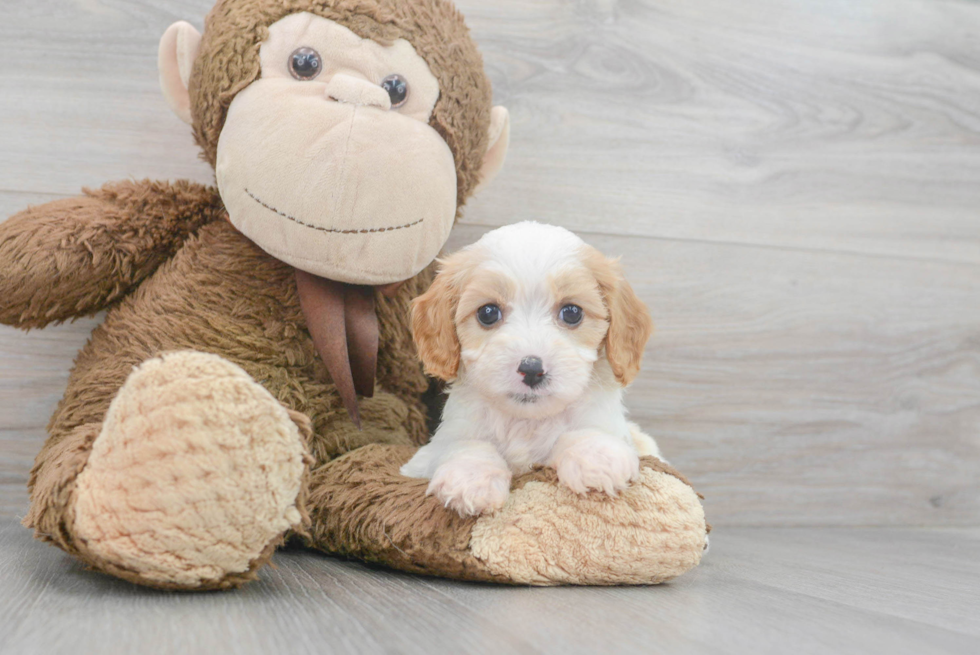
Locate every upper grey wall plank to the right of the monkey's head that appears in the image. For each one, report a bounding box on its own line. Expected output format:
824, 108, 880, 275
462, 0, 980, 263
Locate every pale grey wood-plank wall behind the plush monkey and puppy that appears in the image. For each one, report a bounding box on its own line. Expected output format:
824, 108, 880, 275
0, 0, 980, 526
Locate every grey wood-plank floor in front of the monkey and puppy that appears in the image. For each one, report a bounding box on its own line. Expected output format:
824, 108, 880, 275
0, 520, 980, 655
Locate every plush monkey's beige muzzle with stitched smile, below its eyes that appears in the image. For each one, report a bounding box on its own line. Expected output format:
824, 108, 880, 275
215, 78, 456, 285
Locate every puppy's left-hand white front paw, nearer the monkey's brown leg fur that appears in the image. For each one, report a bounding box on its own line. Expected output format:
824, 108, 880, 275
426, 461, 511, 516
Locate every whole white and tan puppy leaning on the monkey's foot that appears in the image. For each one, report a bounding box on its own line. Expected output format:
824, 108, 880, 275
401, 222, 660, 516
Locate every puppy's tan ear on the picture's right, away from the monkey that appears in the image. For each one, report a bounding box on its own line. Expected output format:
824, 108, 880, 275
584, 246, 653, 386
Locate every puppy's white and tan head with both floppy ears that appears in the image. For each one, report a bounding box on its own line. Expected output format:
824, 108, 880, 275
412, 222, 653, 418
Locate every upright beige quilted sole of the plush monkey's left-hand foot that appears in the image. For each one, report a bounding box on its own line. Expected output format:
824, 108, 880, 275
73, 352, 306, 588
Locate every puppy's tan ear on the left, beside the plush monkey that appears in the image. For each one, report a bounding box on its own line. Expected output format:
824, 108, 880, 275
412, 258, 460, 382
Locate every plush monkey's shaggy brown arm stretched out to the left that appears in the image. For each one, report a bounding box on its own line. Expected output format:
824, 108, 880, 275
0, 180, 223, 328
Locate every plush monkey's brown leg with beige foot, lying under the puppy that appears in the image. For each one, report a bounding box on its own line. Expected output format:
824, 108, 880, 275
310, 446, 706, 585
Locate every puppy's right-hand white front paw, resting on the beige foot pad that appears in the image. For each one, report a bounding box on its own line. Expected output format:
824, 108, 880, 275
555, 435, 640, 496
